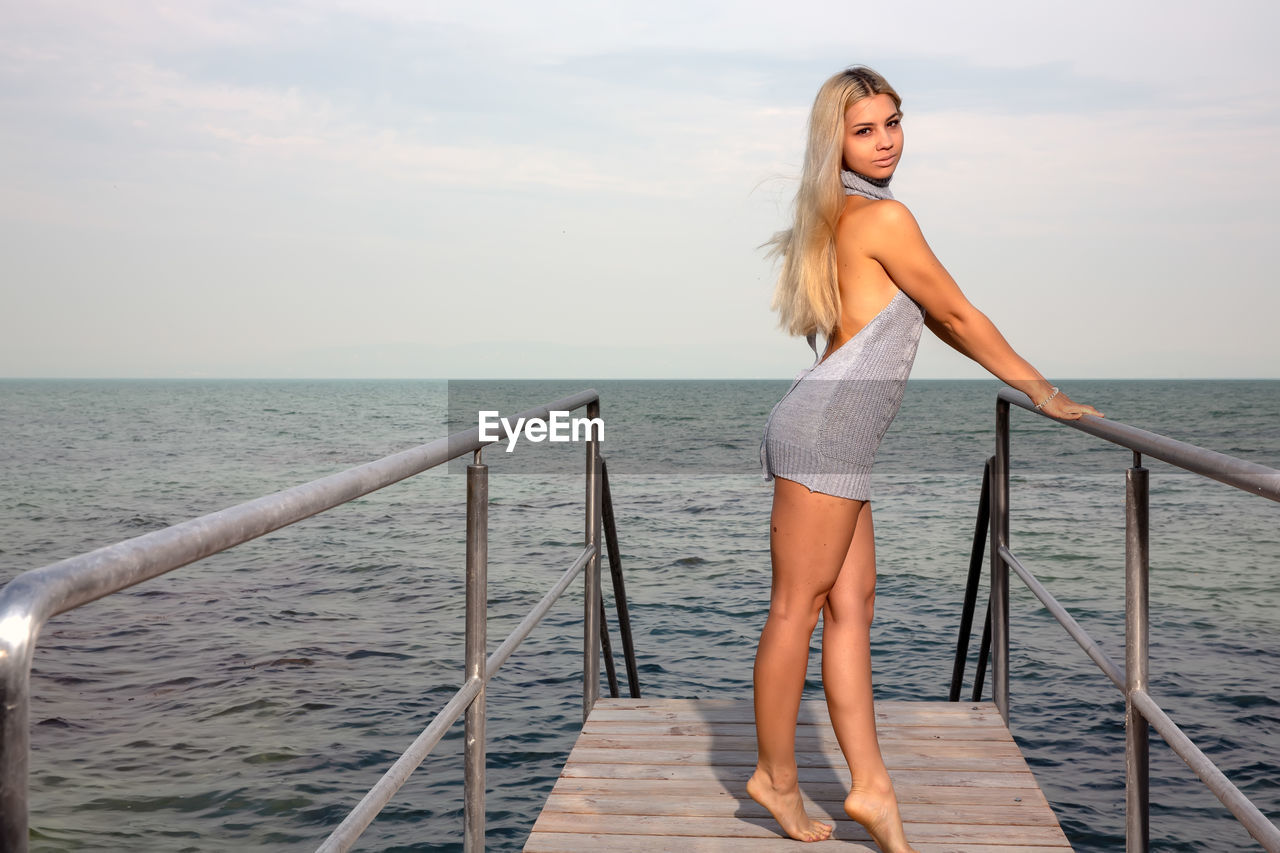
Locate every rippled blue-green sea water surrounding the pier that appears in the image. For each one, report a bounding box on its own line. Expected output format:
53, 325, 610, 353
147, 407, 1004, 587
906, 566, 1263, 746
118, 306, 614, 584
0, 380, 1280, 853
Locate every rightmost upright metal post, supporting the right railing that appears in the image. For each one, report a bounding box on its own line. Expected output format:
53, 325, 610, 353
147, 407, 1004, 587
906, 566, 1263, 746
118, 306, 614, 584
1124, 451, 1151, 853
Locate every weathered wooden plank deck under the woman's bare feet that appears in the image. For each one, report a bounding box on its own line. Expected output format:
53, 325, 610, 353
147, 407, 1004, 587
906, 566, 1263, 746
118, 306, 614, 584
525, 698, 1071, 853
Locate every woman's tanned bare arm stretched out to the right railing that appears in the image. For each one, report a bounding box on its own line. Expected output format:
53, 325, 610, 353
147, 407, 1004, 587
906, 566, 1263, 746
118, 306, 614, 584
859, 201, 1102, 420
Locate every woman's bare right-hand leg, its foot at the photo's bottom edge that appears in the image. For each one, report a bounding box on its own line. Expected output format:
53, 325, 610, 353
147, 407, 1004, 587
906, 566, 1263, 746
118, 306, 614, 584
822, 502, 914, 853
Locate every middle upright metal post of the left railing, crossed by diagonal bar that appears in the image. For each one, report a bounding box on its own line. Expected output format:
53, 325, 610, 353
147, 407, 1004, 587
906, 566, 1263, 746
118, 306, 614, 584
462, 450, 489, 853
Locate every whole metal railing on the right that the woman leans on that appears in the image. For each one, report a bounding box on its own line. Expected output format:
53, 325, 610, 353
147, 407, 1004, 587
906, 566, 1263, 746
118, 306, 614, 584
950, 388, 1280, 853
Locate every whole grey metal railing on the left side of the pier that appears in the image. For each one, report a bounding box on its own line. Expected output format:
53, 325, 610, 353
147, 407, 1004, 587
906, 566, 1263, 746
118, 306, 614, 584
0, 389, 640, 853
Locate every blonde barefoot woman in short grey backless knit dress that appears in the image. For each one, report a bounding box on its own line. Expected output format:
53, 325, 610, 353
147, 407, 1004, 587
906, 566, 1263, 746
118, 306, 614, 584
746, 67, 1102, 853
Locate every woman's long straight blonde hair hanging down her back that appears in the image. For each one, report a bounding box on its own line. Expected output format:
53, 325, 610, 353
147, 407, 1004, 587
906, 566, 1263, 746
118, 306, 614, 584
764, 65, 902, 334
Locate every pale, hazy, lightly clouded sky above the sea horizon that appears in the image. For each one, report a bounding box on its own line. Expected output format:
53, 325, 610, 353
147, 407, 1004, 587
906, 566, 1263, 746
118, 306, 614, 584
0, 0, 1280, 380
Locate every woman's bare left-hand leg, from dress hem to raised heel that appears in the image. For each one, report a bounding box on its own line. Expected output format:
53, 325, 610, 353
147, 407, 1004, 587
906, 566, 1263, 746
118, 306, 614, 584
746, 478, 860, 841
